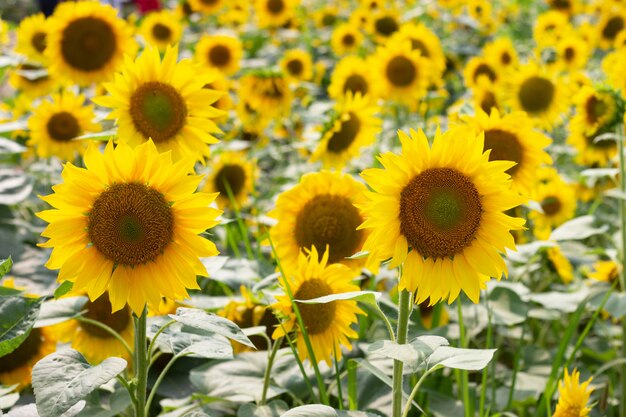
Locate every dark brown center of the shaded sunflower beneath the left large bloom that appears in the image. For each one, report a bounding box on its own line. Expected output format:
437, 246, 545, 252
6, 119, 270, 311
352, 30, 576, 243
78, 293, 130, 339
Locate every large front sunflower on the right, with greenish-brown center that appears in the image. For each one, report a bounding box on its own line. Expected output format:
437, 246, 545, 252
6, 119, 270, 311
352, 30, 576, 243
357, 126, 525, 305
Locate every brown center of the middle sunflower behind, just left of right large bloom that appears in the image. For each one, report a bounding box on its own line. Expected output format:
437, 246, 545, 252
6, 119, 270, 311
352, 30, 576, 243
295, 194, 363, 263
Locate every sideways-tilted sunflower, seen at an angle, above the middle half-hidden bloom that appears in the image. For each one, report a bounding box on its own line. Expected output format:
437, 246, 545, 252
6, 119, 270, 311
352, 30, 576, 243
311, 94, 382, 169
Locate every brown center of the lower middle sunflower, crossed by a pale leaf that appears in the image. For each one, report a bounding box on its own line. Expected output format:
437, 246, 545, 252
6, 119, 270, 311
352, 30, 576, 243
293, 278, 337, 335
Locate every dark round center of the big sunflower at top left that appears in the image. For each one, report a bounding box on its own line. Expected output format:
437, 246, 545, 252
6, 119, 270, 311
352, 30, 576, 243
61, 17, 117, 71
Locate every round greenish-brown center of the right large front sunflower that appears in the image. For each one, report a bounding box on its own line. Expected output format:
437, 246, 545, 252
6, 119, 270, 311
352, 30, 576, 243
400, 168, 483, 258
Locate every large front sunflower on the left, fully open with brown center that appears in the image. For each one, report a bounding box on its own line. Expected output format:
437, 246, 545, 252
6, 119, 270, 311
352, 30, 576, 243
38, 141, 221, 315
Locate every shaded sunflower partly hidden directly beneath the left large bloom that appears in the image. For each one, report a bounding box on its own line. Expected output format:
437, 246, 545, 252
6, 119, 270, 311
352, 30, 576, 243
52, 290, 135, 365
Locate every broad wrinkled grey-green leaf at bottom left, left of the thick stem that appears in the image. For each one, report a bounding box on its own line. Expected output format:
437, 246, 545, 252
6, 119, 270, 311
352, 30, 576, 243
33, 349, 126, 417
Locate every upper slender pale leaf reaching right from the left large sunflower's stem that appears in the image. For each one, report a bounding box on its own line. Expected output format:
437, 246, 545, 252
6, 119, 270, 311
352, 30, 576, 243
169, 307, 256, 349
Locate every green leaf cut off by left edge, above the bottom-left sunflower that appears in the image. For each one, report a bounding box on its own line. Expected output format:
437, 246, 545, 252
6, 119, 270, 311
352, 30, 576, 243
0, 296, 43, 357
